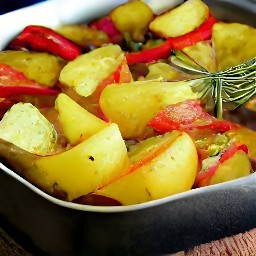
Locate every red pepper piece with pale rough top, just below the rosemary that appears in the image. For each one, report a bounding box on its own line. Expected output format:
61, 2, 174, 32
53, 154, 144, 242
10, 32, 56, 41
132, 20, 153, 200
148, 101, 237, 133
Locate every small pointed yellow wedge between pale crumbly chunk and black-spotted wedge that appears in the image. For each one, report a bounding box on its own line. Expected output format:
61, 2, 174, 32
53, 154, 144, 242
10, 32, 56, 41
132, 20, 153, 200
55, 93, 108, 144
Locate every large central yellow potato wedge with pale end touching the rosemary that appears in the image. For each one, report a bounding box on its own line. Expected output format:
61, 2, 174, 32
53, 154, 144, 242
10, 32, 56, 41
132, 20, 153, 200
100, 81, 197, 139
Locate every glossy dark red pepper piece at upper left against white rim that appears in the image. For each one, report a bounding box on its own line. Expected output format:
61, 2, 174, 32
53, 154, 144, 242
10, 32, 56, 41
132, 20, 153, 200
8, 25, 82, 61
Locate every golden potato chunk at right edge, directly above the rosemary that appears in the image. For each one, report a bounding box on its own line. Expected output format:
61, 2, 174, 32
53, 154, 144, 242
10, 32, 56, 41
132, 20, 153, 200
212, 23, 256, 71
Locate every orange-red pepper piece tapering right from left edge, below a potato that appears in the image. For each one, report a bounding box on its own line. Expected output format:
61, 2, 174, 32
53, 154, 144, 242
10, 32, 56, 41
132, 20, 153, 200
0, 64, 59, 98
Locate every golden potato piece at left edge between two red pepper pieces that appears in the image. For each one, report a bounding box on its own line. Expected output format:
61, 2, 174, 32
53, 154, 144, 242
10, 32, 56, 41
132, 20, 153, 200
0, 51, 66, 86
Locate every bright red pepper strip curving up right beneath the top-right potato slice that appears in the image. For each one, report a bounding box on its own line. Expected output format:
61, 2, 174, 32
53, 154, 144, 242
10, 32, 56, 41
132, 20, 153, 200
171, 14, 217, 50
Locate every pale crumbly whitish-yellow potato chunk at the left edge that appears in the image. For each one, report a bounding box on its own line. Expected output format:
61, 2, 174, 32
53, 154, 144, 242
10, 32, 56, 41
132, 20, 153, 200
0, 103, 58, 155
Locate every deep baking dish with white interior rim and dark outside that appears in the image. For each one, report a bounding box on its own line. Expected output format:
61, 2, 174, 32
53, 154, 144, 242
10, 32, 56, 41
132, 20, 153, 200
0, 0, 256, 256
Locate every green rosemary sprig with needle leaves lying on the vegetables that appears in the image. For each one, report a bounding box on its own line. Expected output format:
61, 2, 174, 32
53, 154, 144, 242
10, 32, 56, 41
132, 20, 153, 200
170, 56, 256, 118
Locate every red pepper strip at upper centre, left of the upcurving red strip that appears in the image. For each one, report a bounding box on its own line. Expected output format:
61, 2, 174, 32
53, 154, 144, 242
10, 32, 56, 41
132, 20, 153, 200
126, 39, 172, 65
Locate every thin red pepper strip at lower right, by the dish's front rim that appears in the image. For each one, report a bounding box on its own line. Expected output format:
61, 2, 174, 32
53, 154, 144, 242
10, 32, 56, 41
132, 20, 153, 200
194, 143, 248, 187
